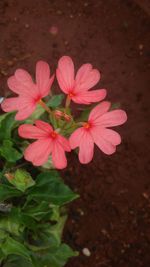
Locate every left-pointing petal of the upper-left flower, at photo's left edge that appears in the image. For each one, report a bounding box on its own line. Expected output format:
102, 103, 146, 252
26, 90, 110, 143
1, 97, 19, 112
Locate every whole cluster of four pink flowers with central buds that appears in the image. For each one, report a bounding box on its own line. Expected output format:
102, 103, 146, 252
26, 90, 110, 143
1, 56, 127, 169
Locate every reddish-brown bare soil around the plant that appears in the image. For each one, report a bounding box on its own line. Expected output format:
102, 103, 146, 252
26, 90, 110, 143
0, 0, 150, 267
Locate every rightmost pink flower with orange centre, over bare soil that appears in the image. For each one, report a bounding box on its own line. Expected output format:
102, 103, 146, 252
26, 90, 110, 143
70, 101, 127, 164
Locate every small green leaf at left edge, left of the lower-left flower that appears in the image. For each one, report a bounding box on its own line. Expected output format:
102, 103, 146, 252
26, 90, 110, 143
0, 140, 23, 163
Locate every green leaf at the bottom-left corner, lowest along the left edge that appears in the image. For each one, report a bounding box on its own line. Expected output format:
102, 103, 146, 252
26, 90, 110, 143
1, 236, 31, 261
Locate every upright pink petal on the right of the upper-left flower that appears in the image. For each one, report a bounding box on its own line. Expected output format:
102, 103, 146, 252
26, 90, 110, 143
36, 61, 54, 97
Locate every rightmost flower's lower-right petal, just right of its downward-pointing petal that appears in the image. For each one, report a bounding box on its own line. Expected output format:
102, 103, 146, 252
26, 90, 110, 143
91, 130, 116, 155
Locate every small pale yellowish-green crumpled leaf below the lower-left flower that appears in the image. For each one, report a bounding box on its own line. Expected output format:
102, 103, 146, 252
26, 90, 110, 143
9, 169, 35, 192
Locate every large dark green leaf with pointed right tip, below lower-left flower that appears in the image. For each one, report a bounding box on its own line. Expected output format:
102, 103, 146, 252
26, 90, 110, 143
27, 171, 78, 206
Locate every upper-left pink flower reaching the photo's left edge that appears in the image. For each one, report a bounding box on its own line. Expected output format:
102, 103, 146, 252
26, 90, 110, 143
1, 61, 54, 120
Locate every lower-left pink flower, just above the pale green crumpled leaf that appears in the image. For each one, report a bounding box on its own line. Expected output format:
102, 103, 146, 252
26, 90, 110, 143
18, 120, 71, 169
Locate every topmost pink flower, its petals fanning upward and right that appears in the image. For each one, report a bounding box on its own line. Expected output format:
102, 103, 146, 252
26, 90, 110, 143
56, 56, 106, 104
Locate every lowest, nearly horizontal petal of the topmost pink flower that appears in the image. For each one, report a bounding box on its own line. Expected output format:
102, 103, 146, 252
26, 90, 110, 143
72, 89, 106, 105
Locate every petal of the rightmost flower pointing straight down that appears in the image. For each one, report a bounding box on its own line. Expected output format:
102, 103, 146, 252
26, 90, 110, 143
79, 130, 94, 164
